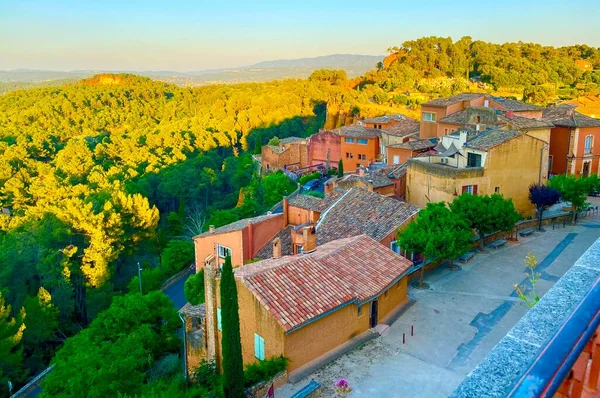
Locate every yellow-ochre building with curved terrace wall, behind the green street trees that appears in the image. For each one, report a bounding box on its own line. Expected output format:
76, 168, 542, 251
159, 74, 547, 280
406, 129, 547, 217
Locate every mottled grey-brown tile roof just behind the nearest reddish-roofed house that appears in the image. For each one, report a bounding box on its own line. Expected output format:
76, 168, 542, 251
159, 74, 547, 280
316, 188, 419, 245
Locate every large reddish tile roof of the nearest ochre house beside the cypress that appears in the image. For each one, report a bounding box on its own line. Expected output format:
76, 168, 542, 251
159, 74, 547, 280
235, 235, 412, 333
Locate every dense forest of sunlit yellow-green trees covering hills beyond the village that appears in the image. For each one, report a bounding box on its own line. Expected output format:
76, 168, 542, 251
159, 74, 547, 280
0, 37, 600, 395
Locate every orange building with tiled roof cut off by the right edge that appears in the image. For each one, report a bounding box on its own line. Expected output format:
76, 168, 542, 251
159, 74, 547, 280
543, 105, 600, 176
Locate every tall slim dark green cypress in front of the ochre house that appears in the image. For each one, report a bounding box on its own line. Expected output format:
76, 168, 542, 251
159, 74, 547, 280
221, 256, 245, 398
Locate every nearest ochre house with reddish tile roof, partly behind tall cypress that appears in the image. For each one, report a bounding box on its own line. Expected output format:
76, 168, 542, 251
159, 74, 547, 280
204, 235, 412, 375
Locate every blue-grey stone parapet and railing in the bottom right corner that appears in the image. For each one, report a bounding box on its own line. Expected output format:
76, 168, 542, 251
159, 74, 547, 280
451, 239, 600, 398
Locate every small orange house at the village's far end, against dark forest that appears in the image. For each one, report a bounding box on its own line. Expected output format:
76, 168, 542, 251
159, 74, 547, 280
261, 137, 309, 171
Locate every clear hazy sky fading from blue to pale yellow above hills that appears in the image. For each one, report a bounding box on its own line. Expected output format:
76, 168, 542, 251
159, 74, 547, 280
0, 0, 600, 71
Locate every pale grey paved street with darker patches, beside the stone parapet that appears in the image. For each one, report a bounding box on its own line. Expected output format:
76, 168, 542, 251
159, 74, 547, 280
276, 204, 600, 398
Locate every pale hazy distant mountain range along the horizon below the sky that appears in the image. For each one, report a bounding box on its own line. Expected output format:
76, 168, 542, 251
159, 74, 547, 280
0, 54, 384, 92
